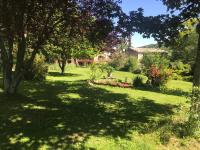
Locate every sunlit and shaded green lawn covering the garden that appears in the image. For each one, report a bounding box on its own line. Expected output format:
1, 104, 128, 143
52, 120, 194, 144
0, 68, 199, 150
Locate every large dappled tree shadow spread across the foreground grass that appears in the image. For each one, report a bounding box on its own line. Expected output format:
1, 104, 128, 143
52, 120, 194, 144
0, 81, 174, 149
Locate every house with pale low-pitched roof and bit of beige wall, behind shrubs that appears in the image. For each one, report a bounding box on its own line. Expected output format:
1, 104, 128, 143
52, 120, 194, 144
126, 47, 167, 61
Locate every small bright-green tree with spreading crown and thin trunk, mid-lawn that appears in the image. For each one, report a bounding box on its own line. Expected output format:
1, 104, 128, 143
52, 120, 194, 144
46, 23, 101, 74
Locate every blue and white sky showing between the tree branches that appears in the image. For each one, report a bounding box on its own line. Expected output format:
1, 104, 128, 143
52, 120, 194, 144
121, 0, 167, 47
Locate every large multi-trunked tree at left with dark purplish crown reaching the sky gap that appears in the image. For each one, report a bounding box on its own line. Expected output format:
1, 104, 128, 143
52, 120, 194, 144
0, 0, 121, 94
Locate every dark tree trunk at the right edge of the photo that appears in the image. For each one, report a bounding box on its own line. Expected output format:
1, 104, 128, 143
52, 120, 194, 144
193, 23, 200, 87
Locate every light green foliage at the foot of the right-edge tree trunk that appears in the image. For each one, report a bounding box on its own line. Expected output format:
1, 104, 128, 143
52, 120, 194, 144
187, 87, 200, 138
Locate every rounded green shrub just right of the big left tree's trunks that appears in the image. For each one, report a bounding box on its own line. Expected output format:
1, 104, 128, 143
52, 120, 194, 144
24, 55, 48, 81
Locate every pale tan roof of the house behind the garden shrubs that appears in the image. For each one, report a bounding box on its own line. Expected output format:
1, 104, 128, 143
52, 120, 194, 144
129, 47, 166, 53
